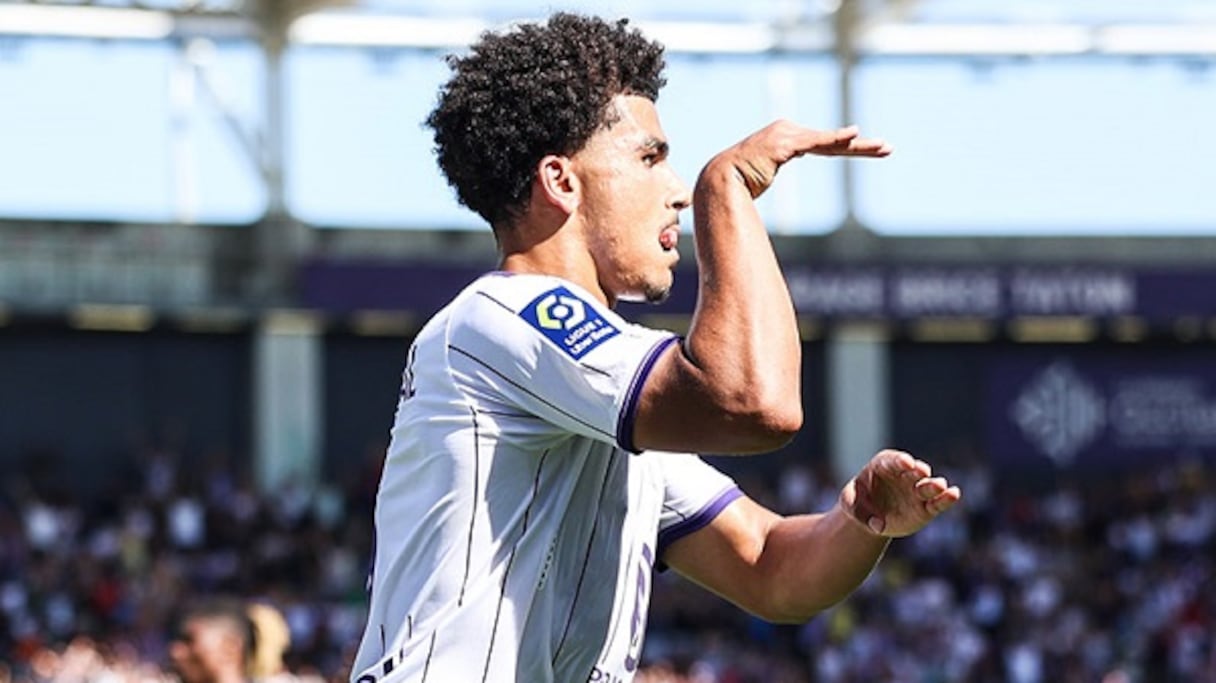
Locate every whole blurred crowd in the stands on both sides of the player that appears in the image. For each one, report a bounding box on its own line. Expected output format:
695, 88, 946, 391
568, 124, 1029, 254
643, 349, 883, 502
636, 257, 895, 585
0, 442, 1216, 683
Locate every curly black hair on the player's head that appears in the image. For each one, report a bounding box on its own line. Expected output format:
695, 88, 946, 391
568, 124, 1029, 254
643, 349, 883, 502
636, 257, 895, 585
427, 12, 666, 228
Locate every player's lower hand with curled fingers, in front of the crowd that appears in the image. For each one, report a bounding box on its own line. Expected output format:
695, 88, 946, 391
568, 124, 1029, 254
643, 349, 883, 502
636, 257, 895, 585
840, 450, 962, 538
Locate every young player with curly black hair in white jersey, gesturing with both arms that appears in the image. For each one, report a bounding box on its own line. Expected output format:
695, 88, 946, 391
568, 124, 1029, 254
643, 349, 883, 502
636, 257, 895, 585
351, 13, 959, 683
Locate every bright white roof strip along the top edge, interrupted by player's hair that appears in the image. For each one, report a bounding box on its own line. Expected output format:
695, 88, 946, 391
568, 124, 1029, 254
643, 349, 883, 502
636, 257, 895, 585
0, 0, 1216, 56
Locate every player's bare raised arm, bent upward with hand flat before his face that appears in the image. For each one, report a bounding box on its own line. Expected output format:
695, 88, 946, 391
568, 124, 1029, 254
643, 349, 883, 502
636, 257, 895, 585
634, 122, 890, 453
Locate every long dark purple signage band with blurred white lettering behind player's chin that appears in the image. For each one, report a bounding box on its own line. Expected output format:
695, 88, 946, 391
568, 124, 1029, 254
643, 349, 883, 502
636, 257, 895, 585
300, 261, 1216, 322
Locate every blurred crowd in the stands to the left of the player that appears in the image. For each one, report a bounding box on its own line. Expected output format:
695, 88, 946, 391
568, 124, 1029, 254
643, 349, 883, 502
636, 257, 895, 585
0, 442, 379, 683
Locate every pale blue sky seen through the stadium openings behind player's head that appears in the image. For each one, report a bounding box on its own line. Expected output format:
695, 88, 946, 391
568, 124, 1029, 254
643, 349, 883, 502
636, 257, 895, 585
0, 2, 1216, 235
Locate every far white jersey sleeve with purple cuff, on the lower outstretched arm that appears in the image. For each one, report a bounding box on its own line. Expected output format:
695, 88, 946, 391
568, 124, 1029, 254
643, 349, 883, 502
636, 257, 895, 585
647, 452, 743, 558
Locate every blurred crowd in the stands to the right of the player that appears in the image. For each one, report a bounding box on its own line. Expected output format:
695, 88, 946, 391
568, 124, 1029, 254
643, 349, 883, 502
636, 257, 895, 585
640, 452, 1216, 683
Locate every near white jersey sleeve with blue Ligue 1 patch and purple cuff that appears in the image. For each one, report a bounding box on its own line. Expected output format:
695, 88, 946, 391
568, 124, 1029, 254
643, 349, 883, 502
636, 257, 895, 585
447, 276, 679, 452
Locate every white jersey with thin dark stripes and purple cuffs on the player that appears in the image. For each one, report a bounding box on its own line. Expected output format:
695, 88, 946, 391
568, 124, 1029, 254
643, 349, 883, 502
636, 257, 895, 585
351, 273, 741, 683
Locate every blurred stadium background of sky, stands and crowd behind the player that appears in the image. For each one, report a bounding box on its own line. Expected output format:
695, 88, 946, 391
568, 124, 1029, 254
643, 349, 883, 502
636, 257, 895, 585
0, 0, 1216, 683
